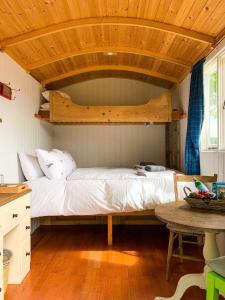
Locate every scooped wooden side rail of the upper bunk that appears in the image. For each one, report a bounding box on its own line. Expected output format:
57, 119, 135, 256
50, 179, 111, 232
50, 92, 172, 124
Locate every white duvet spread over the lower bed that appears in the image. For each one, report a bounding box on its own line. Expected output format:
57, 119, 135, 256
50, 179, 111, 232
28, 168, 175, 217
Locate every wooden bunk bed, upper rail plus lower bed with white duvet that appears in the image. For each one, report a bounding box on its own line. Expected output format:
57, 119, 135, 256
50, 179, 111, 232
30, 90, 185, 245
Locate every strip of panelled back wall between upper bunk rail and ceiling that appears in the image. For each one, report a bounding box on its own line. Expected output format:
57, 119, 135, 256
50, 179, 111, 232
62, 78, 166, 105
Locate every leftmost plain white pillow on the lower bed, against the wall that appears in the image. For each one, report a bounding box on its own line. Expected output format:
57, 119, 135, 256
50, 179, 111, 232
18, 153, 44, 180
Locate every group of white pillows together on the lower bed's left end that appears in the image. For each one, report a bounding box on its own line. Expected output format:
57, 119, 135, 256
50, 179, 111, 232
19, 149, 76, 180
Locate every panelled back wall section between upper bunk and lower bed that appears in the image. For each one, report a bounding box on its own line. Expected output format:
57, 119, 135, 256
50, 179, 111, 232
54, 125, 165, 167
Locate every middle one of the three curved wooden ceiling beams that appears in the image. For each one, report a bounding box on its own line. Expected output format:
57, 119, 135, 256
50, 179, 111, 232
25, 46, 191, 72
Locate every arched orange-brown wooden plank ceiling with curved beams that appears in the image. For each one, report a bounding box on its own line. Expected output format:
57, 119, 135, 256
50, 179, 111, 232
0, 0, 225, 88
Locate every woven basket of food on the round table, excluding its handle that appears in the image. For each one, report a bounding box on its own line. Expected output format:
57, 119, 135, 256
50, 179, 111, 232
184, 197, 225, 212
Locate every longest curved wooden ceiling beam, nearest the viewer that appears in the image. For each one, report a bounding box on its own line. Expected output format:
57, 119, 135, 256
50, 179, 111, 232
0, 17, 215, 50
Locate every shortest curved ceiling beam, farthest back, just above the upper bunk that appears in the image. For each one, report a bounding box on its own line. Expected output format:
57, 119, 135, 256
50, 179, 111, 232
41, 65, 179, 85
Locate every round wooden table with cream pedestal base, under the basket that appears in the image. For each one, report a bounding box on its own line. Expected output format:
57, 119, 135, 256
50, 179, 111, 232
155, 201, 225, 300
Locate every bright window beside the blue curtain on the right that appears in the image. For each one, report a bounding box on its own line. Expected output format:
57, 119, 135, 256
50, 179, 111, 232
201, 47, 225, 151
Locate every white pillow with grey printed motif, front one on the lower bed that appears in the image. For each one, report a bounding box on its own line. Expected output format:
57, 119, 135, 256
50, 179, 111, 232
36, 149, 67, 179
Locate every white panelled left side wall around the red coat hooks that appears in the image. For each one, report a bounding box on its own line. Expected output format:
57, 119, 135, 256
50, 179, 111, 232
0, 53, 52, 182
